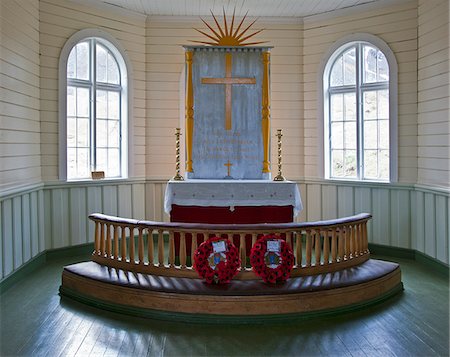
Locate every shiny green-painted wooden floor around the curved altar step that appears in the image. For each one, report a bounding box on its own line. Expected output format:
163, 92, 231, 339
0, 252, 449, 357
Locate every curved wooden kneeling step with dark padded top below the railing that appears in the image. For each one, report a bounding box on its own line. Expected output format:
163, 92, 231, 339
60, 259, 402, 322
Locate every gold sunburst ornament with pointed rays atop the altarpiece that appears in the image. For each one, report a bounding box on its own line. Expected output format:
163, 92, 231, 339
192, 9, 267, 46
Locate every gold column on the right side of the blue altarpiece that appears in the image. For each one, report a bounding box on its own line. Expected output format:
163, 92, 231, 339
261, 52, 270, 173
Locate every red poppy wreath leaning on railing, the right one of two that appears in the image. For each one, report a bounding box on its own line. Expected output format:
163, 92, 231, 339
250, 234, 294, 284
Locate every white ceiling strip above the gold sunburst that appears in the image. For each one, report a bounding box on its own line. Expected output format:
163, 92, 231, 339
75, 0, 398, 17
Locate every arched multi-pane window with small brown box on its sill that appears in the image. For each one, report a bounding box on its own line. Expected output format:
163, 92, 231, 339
60, 30, 128, 180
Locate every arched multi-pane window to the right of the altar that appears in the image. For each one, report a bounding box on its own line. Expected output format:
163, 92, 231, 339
323, 35, 396, 182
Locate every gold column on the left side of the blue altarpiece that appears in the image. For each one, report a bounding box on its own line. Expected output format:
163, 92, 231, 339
185, 51, 194, 172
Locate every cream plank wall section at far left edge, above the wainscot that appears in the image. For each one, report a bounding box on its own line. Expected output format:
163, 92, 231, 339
0, 0, 41, 190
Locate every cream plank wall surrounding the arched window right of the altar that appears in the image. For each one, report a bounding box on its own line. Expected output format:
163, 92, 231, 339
303, 1, 417, 183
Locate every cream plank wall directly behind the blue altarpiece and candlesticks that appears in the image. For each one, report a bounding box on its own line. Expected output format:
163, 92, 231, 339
146, 16, 303, 178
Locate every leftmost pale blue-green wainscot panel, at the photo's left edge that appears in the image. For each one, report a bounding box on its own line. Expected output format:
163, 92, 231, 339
1, 199, 14, 276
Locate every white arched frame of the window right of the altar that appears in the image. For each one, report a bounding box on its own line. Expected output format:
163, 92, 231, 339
317, 33, 398, 183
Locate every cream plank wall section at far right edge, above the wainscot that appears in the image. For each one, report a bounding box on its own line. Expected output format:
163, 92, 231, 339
418, 0, 450, 187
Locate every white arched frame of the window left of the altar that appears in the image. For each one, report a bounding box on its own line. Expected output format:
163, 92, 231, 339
58, 29, 133, 182
